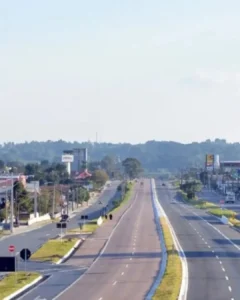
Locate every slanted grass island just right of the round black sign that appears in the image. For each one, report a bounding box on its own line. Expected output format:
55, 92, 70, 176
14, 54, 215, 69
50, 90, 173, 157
31, 239, 78, 262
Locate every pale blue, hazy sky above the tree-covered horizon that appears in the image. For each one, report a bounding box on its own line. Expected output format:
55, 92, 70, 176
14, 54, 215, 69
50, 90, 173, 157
0, 0, 240, 143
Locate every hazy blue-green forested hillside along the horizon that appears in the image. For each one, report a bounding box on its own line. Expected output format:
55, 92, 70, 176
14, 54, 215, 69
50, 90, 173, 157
0, 139, 240, 171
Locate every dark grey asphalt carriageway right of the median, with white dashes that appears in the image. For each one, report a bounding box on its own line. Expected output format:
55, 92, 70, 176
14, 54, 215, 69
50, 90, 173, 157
156, 181, 240, 300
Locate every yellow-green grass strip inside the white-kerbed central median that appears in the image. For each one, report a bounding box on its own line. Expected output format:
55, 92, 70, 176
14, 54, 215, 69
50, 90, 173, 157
152, 218, 182, 300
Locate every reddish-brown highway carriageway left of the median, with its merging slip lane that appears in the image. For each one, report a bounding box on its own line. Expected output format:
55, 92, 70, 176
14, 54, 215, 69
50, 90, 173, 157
20, 180, 161, 300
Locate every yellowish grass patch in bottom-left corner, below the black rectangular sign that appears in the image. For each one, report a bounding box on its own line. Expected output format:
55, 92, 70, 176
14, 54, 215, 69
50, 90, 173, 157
0, 272, 41, 299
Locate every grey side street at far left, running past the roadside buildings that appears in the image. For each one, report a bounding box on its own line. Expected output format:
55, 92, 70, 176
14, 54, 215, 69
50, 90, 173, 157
0, 181, 119, 256
